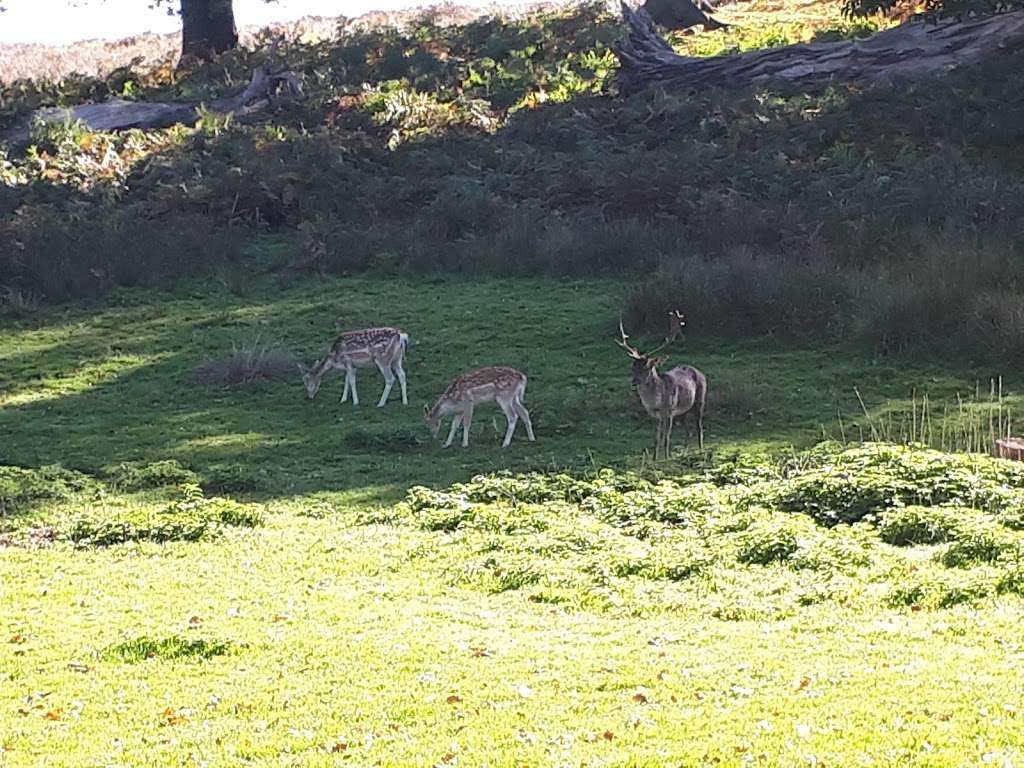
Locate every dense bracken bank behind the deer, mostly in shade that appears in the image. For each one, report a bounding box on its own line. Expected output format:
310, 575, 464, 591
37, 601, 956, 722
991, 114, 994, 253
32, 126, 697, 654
0, 7, 1024, 364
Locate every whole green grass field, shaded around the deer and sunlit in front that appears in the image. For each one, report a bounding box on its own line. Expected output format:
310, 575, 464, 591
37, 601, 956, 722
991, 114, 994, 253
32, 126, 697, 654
0, 279, 1024, 766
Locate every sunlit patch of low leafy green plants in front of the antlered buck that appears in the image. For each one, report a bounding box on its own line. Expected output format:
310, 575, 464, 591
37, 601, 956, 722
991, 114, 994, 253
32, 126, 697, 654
359, 443, 1024, 618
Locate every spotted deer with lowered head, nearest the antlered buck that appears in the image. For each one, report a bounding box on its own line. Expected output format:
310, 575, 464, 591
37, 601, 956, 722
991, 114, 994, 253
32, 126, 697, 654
423, 368, 534, 447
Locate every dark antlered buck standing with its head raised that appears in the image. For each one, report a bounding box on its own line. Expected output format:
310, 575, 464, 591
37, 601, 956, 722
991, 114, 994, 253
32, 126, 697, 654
615, 319, 708, 460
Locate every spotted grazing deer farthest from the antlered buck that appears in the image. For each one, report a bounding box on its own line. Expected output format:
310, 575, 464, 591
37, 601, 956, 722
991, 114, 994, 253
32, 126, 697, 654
299, 328, 409, 408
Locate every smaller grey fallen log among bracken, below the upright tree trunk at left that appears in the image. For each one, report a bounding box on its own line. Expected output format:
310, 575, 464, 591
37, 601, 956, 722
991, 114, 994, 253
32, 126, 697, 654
3, 66, 302, 150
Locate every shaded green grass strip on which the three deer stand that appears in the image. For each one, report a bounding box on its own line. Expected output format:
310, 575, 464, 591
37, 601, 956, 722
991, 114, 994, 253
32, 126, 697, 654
0, 279, 973, 498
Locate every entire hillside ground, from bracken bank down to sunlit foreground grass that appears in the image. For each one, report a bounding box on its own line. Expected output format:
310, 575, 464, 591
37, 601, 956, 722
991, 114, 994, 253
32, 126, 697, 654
0, 0, 1024, 768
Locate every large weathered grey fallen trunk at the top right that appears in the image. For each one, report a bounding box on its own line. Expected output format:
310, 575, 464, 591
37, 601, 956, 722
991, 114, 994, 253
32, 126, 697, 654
615, 3, 1024, 94
